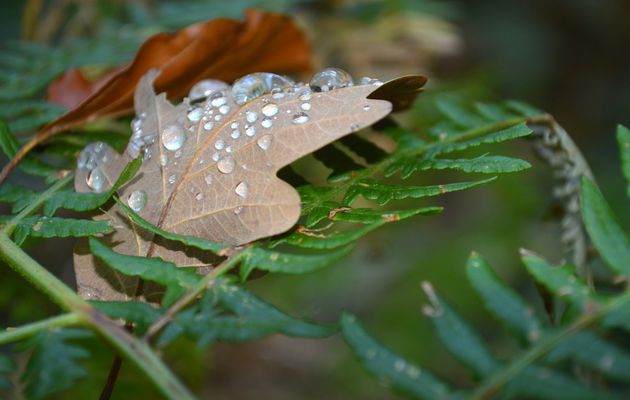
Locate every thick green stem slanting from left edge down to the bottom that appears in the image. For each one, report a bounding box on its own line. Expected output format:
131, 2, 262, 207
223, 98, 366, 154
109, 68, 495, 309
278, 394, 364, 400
0, 232, 194, 400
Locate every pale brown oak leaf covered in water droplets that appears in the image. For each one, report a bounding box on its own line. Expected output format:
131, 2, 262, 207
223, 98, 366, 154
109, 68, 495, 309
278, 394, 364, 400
75, 69, 424, 299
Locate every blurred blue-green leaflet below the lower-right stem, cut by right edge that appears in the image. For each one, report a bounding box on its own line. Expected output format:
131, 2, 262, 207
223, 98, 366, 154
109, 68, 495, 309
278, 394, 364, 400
547, 331, 630, 382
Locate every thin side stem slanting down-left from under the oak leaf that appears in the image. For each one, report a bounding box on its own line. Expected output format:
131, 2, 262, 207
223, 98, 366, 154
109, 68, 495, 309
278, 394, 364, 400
143, 248, 249, 341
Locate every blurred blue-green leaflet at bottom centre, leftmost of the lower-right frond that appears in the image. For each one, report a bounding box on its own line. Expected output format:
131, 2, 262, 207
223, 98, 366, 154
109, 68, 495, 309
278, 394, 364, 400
341, 313, 452, 400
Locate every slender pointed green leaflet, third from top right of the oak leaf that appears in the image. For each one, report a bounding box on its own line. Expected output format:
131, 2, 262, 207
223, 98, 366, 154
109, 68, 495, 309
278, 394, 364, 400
343, 177, 496, 206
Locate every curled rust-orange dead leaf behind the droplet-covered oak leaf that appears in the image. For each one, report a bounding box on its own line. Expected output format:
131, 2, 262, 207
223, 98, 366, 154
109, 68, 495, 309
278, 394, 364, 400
0, 10, 311, 183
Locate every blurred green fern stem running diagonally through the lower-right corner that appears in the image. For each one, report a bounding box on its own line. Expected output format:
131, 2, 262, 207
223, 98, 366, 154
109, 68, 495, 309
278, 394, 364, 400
471, 292, 630, 400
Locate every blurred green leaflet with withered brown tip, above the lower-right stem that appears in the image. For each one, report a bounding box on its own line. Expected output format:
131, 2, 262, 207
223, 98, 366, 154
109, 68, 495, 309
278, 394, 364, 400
424, 292, 499, 377
